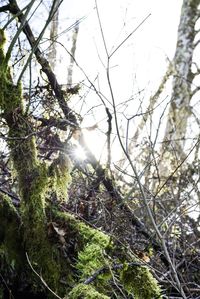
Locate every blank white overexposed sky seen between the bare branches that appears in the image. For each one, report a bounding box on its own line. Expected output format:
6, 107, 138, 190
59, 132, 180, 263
53, 0, 182, 161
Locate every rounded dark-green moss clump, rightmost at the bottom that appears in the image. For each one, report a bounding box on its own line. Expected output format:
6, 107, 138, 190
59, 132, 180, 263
120, 265, 162, 299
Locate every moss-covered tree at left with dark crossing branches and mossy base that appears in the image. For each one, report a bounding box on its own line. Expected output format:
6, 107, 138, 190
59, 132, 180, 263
0, 0, 161, 298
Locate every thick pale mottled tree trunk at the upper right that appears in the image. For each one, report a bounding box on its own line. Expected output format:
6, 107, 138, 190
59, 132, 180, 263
160, 0, 200, 177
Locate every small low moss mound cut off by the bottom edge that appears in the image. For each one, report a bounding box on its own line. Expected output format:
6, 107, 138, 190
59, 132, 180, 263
67, 284, 109, 299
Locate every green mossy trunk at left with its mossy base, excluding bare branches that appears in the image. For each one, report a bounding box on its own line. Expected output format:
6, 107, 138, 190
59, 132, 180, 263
0, 25, 161, 299
